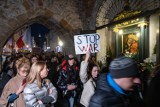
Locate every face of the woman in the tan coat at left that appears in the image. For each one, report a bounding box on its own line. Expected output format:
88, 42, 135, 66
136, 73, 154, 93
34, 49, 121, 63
18, 64, 30, 77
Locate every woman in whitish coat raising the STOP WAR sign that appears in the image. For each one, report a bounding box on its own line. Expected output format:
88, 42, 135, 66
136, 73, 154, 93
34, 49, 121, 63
79, 52, 99, 107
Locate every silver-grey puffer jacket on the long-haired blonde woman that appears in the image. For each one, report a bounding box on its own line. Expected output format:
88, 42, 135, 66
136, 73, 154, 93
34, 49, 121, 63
24, 80, 57, 107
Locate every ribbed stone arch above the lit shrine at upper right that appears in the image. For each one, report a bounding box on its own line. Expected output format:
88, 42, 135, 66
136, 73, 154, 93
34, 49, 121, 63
96, 0, 160, 27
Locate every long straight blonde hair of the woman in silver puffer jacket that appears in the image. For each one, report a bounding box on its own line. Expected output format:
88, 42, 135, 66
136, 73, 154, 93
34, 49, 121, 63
27, 61, 46, 88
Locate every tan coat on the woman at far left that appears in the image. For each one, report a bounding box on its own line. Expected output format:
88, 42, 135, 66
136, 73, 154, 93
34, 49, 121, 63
0, 74, 25, 107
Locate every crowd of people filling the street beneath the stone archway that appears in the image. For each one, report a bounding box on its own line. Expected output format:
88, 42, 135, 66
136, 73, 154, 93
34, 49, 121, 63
0, 52, 160, 107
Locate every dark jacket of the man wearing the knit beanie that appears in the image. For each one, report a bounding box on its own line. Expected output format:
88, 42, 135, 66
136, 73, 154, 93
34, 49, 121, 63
89, 74, 142, 107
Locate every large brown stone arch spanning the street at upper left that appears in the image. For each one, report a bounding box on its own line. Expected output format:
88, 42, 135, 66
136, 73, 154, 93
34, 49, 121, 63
0, 0, 82, 53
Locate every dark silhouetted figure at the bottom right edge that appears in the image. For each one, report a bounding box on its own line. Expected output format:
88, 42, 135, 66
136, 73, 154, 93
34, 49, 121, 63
145, 69, 160, 107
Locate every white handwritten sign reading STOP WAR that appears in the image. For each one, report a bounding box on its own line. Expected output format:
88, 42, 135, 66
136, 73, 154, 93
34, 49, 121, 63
74, 34, 100, 54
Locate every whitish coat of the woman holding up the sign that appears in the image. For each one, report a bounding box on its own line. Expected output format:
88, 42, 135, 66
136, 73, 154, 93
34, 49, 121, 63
79, 61, 96, 107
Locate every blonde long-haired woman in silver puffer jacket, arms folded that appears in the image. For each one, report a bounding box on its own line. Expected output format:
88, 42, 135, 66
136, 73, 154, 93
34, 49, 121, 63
24, 61, 57, 107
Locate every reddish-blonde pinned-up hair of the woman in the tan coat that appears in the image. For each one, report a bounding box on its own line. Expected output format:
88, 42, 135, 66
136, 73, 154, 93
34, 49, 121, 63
16, 57, 30, 73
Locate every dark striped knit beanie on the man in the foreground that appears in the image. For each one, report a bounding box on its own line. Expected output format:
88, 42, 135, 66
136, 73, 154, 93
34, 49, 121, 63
109, 56, 139, 78
